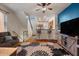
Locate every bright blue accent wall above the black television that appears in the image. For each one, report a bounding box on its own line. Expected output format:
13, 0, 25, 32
58, 3, 79, 23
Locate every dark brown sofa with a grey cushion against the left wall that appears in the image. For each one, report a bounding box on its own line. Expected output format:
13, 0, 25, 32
0, 32, 19, 47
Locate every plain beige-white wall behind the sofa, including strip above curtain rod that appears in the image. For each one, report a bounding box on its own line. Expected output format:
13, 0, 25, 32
0, 5, 27, 41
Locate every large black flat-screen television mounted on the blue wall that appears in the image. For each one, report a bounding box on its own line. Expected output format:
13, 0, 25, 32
60, 18, 79, 36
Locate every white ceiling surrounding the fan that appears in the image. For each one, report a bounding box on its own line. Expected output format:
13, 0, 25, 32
2, 3, 70, 25
